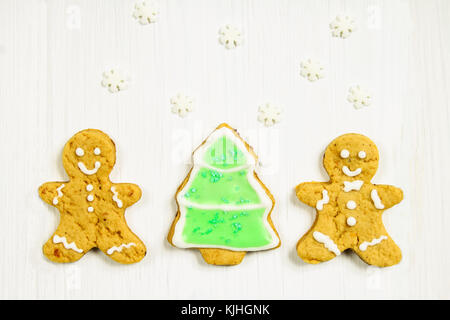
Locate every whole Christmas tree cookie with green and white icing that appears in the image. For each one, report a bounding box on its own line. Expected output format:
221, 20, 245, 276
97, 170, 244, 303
168, 124, 280, 265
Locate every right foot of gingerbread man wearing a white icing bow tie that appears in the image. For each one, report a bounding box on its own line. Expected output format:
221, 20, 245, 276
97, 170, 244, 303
353, 236, 402, 267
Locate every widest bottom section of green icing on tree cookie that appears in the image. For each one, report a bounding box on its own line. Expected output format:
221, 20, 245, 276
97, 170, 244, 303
182, 207, 272, 249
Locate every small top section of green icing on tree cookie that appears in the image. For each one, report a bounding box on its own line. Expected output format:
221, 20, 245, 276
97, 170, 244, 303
203, 136, 246, 169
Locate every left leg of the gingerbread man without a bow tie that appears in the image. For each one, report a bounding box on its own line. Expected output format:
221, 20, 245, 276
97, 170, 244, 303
42, 221, 93, 263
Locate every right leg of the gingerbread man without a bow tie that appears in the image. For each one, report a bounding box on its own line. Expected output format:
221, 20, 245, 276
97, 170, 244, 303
97, 222, 147, 264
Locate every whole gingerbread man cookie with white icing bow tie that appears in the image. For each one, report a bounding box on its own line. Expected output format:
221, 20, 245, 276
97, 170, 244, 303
296, 133, 403, 267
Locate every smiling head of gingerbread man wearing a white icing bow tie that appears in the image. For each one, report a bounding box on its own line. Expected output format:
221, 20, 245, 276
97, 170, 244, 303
323, 134, 379, 182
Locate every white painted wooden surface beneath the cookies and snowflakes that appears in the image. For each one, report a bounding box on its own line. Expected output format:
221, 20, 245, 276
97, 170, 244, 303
0, 0, 450, 299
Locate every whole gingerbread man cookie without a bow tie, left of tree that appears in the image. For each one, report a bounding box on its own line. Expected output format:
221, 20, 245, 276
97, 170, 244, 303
39, 129, 146, 264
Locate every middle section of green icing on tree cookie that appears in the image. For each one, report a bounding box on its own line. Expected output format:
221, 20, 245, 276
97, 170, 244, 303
184, 168, 261, 205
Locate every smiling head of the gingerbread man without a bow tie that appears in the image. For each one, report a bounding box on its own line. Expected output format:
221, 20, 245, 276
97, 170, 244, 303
63, 129, 116, 179
